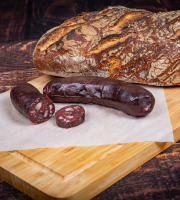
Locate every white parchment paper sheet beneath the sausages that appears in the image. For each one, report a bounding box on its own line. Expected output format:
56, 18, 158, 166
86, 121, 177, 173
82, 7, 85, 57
0, 87, 174, 151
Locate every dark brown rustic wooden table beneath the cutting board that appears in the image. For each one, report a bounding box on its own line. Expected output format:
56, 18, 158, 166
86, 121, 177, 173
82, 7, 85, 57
0, 0, 180, 200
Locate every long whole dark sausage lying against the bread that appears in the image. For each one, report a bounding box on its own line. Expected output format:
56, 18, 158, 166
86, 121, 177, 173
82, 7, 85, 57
43, 76, 155, 117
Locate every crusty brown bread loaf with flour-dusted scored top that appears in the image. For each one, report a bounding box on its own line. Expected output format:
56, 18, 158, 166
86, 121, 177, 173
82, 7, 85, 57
33, 6, 180, 86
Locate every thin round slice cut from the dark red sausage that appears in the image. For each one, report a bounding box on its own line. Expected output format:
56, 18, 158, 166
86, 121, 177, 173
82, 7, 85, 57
55, 105, 85, 128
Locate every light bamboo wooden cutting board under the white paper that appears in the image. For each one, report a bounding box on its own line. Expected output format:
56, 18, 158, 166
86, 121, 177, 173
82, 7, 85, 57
0, 75, 180, 200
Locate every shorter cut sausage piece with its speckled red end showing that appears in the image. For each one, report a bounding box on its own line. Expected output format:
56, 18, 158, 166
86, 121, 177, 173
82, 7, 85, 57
10, 83, 55, 124
